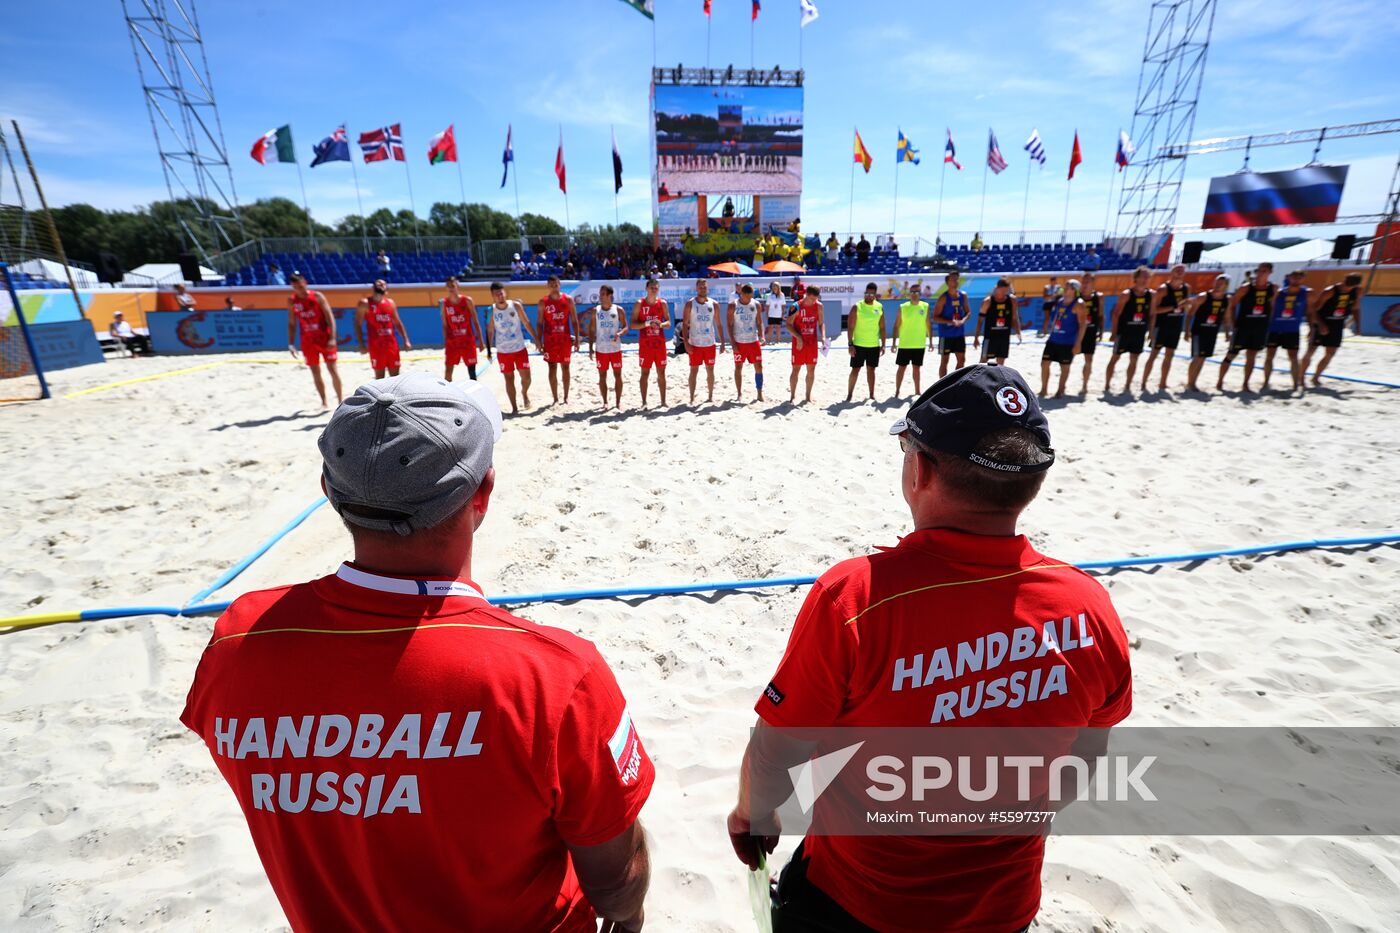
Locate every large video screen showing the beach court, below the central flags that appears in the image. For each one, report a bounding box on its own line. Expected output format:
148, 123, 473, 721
655, 84, 802, 199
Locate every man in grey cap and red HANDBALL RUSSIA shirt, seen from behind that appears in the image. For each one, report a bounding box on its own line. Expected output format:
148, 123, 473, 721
181, 374, 655, 933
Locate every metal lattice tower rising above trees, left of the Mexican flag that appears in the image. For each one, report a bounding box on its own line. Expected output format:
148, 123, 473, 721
122, 0, 244, 262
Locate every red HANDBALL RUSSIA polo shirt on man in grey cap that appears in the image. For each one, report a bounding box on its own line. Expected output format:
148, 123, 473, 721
181, 565, 655, 932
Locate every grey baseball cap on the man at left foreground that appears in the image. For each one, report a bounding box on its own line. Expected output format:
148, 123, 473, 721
318, 373, 501, 535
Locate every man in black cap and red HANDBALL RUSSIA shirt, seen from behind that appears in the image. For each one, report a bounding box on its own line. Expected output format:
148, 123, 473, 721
728, 364, 1133, 933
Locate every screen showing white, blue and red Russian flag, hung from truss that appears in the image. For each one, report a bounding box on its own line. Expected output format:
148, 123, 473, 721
1201, 165, 1348, 230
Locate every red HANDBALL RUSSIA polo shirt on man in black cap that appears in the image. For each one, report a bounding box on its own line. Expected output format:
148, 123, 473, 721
756, 530, 1133, 933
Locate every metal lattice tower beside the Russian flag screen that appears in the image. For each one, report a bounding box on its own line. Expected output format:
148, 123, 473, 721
1114, 0, 1215, 237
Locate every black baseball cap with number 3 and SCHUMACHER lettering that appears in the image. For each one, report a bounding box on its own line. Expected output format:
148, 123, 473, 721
889, 364, 1054, 474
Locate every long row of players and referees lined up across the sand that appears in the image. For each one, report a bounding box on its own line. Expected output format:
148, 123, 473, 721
278, 263, 1362, 413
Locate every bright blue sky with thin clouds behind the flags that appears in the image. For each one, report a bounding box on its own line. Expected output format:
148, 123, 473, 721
0, 0, 1400, 246
